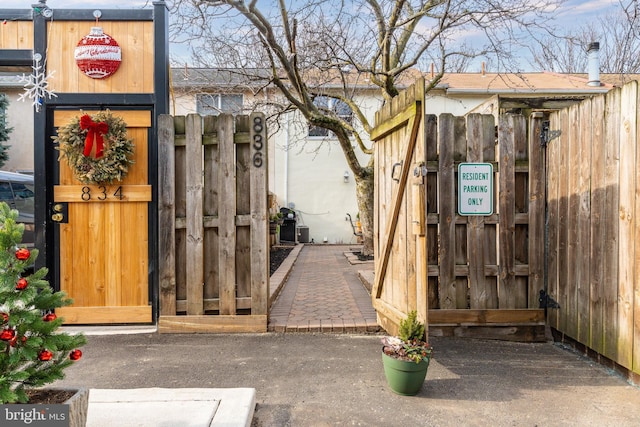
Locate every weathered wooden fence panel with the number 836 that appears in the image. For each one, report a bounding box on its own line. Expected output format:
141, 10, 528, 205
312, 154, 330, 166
158, 113, 269, 332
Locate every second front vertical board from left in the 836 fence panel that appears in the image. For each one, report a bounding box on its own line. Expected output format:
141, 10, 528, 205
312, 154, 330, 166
186, 114, 204, 315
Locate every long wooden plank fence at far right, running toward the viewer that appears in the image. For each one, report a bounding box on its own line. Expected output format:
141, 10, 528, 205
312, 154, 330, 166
547, 81, 640, 374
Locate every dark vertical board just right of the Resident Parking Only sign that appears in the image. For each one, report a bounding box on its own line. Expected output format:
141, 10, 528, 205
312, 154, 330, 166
498, 114, 517, 308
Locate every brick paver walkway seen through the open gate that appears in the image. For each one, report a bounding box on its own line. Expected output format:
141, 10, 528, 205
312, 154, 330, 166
269, 245, 379, 332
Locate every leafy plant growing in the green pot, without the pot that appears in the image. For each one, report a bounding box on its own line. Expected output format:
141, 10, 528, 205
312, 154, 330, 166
382, 311, 433, 363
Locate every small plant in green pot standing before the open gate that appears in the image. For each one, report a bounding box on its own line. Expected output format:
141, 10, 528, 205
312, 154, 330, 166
382, 311, 433, 396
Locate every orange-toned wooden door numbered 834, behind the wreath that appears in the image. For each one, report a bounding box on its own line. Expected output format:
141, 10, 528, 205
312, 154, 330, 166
54, 110, 152, 324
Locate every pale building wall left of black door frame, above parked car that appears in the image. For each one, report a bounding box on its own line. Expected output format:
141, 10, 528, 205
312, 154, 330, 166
0, 88, 33, 172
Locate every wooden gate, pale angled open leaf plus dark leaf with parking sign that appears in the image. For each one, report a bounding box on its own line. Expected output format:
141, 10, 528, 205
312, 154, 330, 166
372, 77, 545, 340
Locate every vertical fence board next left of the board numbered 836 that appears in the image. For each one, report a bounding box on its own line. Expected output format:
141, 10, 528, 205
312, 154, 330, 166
218, 114, 236, 315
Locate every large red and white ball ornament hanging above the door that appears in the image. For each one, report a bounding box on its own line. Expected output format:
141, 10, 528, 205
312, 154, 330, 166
74, 27, 122, 79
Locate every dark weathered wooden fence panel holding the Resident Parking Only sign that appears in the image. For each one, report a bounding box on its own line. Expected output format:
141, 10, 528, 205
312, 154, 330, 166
426, 114, 545, 341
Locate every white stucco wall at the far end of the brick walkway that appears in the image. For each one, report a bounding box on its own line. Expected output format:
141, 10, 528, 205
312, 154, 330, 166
269, 96, 380, 244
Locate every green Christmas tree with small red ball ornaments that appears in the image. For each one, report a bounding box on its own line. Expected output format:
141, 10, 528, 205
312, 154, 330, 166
0, 203, 86, 403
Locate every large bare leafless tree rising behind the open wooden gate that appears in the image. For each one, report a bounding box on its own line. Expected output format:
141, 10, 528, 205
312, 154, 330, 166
172, 0, 561, 254
